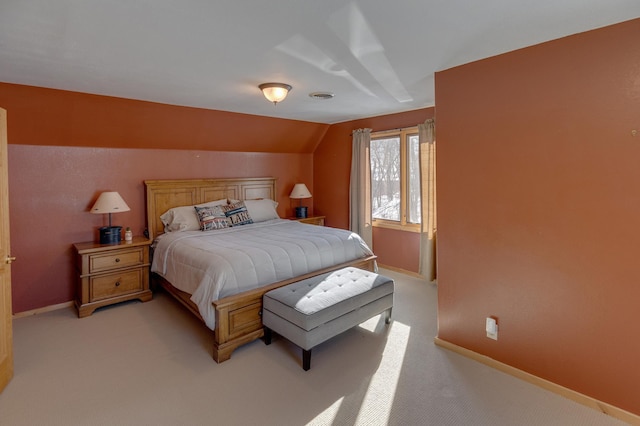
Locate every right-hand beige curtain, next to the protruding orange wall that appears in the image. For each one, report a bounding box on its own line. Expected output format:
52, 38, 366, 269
418, 119, 437, 281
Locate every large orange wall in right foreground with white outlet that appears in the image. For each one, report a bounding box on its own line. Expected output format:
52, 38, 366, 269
436, 20, 640, 415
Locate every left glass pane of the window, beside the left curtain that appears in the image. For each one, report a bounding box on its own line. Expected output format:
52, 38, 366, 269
371, 137, 400, 222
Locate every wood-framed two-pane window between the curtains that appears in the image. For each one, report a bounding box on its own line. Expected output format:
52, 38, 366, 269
370, 127, 421, 231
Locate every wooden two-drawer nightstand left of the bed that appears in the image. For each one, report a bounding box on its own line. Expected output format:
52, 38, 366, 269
73, 237, 152, 318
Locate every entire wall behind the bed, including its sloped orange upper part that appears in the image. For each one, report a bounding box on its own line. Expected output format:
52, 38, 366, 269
0, 84, 318, 313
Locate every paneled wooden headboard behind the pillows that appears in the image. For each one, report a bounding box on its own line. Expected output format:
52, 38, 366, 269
144, 177, 276, 239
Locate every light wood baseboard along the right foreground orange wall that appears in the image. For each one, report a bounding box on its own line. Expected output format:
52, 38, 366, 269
434, 337, 640, 425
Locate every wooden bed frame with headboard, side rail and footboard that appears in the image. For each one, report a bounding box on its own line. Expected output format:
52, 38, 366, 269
144, 178, 376, 363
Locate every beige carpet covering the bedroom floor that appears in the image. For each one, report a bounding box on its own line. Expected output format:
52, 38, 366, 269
0, 271, 623, 426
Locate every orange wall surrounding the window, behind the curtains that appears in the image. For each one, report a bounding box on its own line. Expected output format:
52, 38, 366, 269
313, 108, 434, 272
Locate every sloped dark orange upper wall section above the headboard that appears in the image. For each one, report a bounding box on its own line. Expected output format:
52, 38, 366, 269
0, 83, 329, 153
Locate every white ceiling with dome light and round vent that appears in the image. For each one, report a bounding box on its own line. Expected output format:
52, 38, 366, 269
0, 0, 640, 123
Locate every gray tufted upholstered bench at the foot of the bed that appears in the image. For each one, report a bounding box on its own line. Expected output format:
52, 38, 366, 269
262, 267, 394, 371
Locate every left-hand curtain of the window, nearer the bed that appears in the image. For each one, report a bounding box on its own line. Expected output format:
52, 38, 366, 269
349, 129, 373, 250
